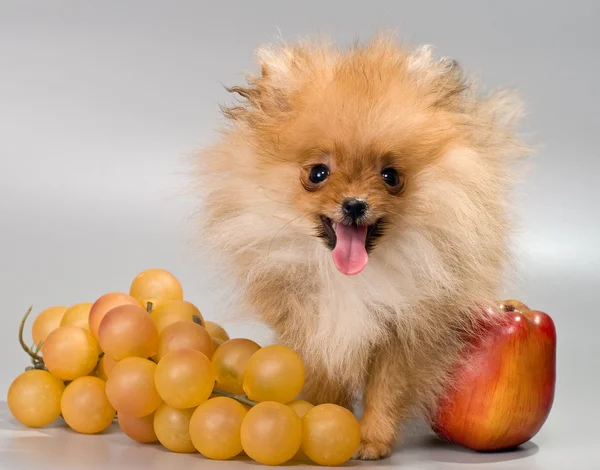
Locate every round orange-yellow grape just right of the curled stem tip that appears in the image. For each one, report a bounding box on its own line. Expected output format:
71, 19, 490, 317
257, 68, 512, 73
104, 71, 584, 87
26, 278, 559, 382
42, 326, 100, 380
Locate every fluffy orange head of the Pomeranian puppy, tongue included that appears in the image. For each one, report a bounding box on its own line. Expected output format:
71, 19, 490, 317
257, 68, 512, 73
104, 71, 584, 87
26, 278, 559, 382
197, 35, 521, 290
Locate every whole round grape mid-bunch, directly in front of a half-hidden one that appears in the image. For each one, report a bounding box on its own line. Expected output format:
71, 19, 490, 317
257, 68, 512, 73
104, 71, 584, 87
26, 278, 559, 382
155, 348, 215, 409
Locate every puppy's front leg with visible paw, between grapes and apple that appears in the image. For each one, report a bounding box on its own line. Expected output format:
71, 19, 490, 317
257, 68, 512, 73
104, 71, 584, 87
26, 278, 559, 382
355, 345, 408, 460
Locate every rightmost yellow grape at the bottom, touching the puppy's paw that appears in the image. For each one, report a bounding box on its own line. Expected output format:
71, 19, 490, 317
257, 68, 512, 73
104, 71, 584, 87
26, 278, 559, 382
302, 403, 360, 466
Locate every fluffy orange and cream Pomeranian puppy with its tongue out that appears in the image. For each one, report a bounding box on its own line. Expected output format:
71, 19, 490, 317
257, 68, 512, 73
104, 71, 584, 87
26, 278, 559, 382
195, 36, 527, 459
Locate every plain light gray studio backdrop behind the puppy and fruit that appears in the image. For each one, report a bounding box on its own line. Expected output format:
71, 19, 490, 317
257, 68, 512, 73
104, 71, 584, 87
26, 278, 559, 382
0, 0, 600, 462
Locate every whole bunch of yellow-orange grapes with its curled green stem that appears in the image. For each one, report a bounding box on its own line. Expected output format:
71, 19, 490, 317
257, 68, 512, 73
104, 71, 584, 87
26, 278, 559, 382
8, 269, 360, 465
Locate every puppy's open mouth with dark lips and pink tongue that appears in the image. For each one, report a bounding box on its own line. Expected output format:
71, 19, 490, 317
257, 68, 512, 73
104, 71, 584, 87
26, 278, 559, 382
319, 215, 384, 276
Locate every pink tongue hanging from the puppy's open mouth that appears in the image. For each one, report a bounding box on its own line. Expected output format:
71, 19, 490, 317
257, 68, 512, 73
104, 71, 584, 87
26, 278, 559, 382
333, 224, 369, 276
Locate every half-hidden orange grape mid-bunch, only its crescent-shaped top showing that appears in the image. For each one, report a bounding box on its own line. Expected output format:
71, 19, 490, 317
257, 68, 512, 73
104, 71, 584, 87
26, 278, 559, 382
156, 320, 212, 361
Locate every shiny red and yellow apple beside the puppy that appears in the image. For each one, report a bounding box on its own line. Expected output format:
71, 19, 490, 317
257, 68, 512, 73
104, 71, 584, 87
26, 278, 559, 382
432, 301, 556, 452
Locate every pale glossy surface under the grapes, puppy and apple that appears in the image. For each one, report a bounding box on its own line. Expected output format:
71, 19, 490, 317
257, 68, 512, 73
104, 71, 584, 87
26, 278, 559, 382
0, 403, 600, 470
